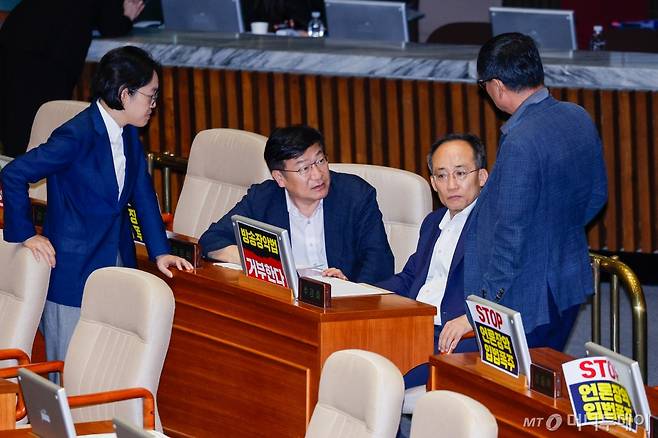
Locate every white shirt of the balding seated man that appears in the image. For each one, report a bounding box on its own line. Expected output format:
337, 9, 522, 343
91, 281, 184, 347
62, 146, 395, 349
416, 199, 477, 325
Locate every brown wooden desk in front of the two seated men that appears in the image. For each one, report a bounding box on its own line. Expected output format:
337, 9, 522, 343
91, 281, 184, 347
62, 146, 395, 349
139, 255, 435, 437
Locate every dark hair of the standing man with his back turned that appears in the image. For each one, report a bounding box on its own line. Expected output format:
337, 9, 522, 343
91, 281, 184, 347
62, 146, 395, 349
477, 32, 544, 91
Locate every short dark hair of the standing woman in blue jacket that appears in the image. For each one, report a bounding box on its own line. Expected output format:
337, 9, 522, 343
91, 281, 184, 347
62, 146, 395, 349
91, 46, 160, 110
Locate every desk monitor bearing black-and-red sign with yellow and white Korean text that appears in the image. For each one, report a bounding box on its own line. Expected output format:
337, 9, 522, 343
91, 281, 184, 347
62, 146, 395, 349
231, 214, 298, 298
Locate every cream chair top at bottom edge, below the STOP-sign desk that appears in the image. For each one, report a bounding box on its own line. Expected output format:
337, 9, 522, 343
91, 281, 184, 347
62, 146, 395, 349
410, 391, 498, 438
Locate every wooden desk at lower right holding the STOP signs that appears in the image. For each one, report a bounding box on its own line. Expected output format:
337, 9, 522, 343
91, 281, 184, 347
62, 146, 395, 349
428, 348, 658, 438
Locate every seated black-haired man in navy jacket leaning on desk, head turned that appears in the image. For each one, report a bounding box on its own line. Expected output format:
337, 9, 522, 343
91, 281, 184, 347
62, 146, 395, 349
199, 126, 393, 283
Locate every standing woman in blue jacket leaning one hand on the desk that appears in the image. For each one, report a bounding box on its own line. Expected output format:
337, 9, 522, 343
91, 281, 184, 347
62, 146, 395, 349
0, 46, 192, 360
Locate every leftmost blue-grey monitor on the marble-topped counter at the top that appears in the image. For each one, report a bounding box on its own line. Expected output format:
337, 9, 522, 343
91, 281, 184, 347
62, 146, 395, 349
162, 0, 244, 33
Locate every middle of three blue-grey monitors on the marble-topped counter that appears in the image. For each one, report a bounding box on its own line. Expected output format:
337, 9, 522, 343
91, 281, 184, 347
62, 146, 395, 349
324, 0, 409, 43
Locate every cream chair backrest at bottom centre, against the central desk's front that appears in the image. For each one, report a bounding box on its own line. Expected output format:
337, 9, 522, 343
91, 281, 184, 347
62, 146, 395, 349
306, 350, 404, 438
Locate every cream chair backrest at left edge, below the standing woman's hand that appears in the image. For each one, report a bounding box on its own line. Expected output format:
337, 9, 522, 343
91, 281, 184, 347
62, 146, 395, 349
0, 230, 50, 368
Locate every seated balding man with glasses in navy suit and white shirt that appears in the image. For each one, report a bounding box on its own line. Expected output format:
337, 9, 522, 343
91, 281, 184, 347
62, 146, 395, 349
378, 134, 488, 387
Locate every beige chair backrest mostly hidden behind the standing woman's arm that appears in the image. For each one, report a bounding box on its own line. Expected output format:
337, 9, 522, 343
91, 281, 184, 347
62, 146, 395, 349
27, 100, 89, 201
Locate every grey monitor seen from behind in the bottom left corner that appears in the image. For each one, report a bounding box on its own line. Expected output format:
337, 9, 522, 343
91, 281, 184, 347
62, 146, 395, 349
18, 369, 76, 438
